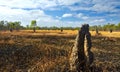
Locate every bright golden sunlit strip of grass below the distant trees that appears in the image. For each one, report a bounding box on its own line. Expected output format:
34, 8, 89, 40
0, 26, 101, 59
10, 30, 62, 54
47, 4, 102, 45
1, 30, 120, 38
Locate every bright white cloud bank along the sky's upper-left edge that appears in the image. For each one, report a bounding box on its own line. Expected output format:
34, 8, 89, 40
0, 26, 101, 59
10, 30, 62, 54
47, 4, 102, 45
0, 0, 81, 9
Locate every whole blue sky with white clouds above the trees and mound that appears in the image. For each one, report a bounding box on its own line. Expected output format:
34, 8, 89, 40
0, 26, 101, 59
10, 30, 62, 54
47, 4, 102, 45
0, 0, 120, 27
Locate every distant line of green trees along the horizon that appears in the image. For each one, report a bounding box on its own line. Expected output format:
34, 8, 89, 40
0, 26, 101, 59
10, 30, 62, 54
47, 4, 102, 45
0, 20, 120, 32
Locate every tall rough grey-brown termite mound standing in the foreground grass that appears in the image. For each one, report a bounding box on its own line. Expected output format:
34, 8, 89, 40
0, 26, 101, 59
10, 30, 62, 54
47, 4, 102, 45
70, 24, 93, 72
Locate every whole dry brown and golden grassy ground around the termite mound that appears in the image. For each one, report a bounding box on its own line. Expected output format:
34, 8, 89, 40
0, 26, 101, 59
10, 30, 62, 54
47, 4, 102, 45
0, 30, 120, 72
